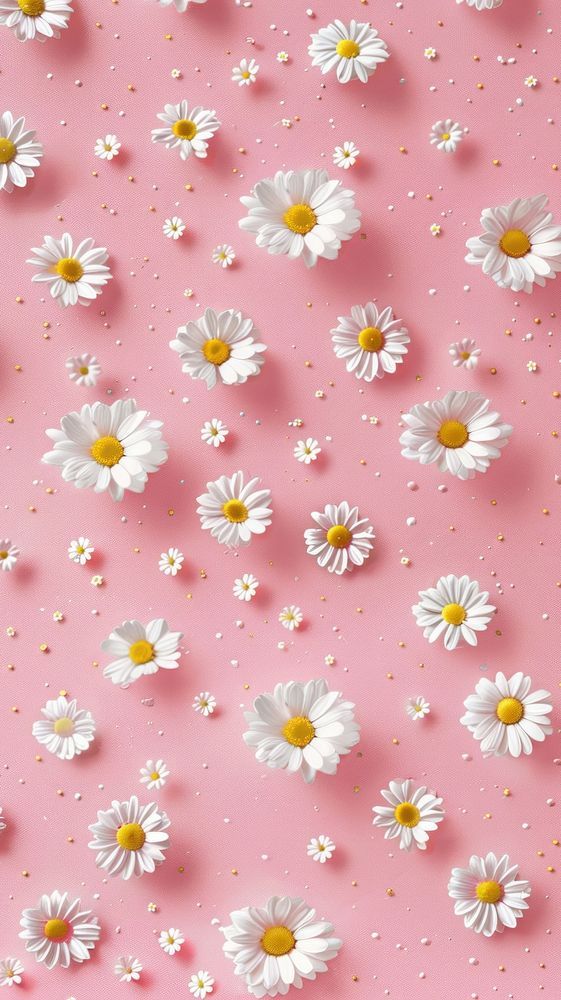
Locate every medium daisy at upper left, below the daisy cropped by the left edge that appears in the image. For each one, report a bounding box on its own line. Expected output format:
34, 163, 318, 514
27, 232, 113, 306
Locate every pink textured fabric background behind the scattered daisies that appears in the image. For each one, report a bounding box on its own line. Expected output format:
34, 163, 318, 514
0, 0, 561, 1000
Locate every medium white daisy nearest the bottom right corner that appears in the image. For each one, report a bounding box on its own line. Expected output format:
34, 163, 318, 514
448, 852, 532, 937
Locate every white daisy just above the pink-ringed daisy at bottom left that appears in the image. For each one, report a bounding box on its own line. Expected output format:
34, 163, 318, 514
88, 795, 170, 879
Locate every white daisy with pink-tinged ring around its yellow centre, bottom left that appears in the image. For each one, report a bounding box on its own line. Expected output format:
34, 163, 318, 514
19, 892, 99, 969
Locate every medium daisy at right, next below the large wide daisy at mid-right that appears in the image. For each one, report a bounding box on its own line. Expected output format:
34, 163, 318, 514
411, 573, 497, 649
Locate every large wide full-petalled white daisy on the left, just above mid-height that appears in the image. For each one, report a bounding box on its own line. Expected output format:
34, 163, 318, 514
43, 399, 168, 500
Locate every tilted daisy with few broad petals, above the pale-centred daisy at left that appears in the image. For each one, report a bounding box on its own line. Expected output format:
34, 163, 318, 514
101, 618, 183, 687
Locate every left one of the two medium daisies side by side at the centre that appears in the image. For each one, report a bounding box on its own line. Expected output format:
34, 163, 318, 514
197, 472, 273, 548
